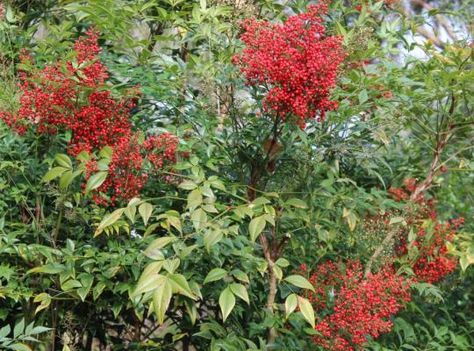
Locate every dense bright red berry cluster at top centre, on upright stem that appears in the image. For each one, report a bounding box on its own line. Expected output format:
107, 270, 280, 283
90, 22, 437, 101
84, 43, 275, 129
234, 0, 345, 127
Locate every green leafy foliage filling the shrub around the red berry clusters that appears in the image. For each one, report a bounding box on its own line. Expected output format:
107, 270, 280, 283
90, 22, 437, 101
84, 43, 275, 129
0, 0, 474, 351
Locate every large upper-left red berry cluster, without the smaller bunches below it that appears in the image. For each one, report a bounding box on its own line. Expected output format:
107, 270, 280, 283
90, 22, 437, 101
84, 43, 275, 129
2, 30, 134, 155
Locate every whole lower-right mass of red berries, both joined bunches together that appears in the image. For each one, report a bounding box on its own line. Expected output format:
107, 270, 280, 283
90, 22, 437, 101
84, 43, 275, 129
301, 178, 464, 351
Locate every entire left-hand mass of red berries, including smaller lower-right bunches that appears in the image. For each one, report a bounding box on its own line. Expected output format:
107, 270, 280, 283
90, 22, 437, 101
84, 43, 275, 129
0, 30, 179, 203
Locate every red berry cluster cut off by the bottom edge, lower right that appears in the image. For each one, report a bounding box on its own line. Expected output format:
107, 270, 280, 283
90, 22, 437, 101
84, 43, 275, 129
308, 261, 411, 351
